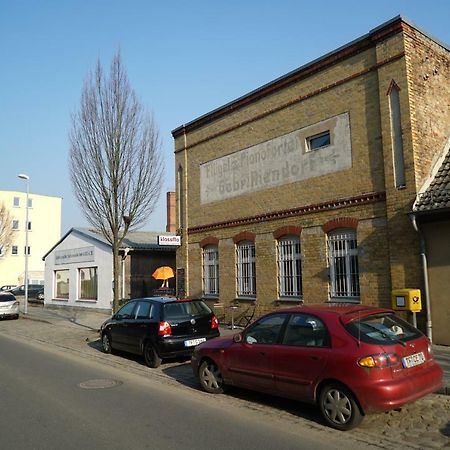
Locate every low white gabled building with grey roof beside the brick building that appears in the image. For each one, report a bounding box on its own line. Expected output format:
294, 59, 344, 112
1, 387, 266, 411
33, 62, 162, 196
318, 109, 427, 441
43, 228, 177, 311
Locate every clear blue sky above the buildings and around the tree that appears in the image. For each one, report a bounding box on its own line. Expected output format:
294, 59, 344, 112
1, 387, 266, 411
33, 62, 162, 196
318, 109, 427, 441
0, 0, 450, 233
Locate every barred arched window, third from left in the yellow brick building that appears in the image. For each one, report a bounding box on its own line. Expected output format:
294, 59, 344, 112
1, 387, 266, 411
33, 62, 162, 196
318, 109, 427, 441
277, 236, 302, 298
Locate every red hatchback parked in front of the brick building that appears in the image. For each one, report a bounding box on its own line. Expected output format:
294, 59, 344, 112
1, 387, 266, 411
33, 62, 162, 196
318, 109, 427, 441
192, 304, 443, 430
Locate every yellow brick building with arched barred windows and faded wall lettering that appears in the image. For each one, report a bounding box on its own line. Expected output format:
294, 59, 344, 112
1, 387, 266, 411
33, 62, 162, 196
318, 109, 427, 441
172, 17, 450, 342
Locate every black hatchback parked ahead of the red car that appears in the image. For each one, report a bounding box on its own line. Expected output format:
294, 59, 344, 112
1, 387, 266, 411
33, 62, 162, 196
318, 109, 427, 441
100, 297, 220, 368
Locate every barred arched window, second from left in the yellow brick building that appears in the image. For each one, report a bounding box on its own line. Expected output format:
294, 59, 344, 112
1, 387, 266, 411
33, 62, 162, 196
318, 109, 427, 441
236, 241, 256, 297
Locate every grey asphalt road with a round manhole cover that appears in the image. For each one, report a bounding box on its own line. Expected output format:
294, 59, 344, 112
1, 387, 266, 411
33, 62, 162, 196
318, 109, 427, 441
0, 336, 356, 450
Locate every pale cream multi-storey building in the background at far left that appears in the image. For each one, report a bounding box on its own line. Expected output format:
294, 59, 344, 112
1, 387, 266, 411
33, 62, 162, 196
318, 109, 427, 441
0, 191, 62, 286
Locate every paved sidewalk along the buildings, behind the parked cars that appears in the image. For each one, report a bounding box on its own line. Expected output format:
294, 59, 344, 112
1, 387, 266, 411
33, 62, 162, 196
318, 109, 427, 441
22, 304, 450, 395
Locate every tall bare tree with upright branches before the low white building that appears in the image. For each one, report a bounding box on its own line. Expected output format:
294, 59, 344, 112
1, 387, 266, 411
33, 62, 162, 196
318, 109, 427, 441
69, 53, 164, 311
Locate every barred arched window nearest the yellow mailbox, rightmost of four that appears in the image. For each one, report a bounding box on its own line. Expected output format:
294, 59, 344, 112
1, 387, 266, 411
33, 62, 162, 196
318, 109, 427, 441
328, 228, 359, 300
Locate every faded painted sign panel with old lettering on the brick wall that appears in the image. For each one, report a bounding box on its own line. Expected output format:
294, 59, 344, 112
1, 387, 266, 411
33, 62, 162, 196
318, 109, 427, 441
200, 113, 352, 204
